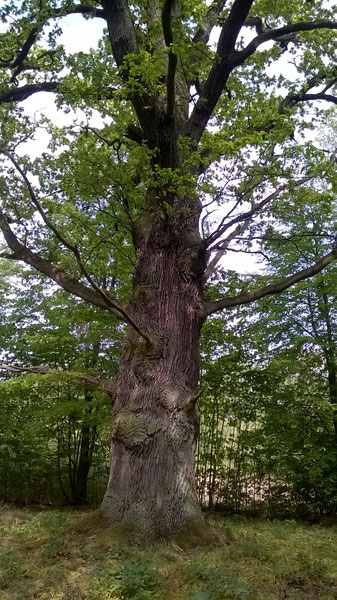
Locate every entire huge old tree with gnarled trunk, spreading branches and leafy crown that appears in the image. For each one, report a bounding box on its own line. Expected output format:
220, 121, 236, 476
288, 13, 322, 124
0, 0, 337, 537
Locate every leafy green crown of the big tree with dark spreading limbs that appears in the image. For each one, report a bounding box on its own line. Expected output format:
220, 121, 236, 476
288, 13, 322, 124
0, 1, 337, 327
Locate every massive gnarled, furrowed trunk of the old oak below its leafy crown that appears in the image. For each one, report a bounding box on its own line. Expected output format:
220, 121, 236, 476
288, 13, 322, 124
101, 203, 203, 538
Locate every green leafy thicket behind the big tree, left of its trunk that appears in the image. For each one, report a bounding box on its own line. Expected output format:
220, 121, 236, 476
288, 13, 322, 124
0, 263, 118, 504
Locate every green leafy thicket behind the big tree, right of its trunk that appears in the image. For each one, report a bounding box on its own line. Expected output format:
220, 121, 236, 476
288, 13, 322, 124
194, 188, 336, 515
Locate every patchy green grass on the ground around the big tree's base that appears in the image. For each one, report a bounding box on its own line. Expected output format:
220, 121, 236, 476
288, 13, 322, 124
0, 507, 337, 600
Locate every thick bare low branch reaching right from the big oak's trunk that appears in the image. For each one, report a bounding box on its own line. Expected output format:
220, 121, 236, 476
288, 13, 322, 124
206, 248, 337, 315
